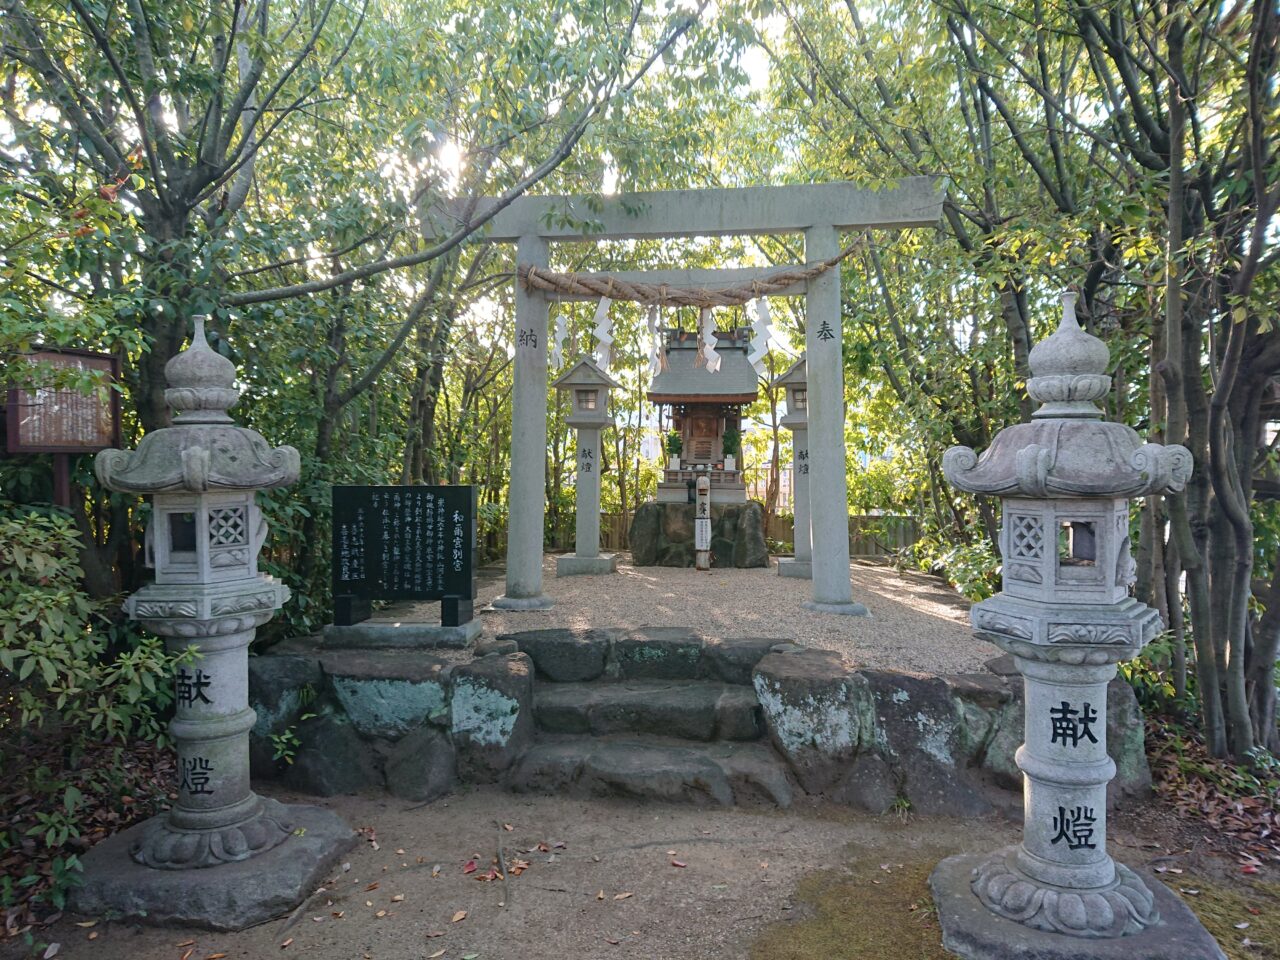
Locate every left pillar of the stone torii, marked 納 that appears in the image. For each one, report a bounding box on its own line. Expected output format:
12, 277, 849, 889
493, 234, 552, 611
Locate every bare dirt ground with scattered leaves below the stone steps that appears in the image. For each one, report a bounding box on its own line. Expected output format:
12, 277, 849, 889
37, 788, 1259, 960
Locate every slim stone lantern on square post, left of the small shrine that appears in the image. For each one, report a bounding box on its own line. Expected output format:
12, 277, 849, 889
552, 356, 620, 577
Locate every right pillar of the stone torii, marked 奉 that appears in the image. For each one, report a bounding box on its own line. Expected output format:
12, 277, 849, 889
804, 227, 868, 617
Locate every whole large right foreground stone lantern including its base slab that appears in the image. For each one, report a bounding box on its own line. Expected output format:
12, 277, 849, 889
931, 293, 1219, 960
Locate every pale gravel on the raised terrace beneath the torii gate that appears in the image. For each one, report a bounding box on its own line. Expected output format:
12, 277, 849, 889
386, 554, 1000, 673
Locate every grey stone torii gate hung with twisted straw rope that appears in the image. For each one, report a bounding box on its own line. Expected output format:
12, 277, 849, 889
455, 177, 943, 616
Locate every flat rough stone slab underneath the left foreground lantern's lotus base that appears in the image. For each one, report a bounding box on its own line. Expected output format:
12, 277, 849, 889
70, 806, 357, 931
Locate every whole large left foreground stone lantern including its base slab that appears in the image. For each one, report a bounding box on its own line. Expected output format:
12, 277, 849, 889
77, 317, 351, 928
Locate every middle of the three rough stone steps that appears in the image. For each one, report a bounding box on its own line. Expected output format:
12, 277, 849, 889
534, 680, 764, 740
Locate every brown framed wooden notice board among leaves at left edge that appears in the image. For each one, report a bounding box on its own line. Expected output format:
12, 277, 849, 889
5, 349, 120, 453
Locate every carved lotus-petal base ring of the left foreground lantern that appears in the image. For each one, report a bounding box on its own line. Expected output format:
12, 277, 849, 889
129, 794, 294, 870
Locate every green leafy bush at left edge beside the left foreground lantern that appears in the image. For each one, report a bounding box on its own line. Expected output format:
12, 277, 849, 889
0, 500, 187, 931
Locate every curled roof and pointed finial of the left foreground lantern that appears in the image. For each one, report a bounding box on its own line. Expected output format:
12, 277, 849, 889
93, 316, 301, 494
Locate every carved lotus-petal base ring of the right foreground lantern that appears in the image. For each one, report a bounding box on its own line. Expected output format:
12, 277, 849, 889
973, 847, 1160, 937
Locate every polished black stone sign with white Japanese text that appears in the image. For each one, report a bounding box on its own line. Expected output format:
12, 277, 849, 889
333, 486, 476, 626
